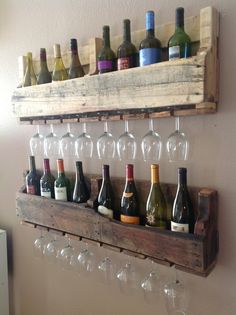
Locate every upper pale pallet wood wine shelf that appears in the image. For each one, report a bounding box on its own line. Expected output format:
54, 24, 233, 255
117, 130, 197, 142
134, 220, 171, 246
12, 7, 219, 124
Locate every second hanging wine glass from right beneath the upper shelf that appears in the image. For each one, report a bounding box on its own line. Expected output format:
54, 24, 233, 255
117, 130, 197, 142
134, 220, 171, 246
141, 119, 162, 162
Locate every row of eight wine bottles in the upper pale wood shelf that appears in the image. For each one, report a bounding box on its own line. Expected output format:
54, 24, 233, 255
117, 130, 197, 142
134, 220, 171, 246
22, 8, 191, 87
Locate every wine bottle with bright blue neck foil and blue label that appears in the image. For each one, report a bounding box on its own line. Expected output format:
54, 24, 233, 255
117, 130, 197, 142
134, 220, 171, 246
139, 11, 161, 67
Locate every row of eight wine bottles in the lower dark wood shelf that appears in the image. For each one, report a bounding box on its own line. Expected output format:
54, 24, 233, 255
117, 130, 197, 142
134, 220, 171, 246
26, 156, 195, 233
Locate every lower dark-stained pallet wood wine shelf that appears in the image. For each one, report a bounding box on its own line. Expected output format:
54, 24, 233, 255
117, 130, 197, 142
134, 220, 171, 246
16, 178, 218, 276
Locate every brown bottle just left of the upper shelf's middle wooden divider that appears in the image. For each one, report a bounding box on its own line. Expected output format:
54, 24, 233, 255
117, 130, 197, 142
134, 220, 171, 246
68, 38, 85, 79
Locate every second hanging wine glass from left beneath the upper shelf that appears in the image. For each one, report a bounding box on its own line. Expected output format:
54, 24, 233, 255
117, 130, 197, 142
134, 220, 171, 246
44, 124, 60, 159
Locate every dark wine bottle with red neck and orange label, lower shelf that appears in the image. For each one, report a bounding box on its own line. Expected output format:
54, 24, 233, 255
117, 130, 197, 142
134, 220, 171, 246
120, 164, 140, 224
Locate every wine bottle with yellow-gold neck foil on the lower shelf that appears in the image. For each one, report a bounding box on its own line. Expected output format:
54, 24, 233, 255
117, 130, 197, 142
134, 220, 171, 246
146, 164, 167, 229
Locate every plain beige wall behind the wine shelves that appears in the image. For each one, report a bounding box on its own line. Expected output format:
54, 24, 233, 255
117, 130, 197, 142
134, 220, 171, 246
0, 0, 236, 315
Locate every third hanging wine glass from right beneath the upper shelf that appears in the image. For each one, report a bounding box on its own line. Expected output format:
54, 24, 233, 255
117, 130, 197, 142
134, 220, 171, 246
117, 120, 137, 160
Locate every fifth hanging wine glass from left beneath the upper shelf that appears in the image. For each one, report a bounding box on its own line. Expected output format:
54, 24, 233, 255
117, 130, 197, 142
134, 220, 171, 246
97, 121, 116, 159
